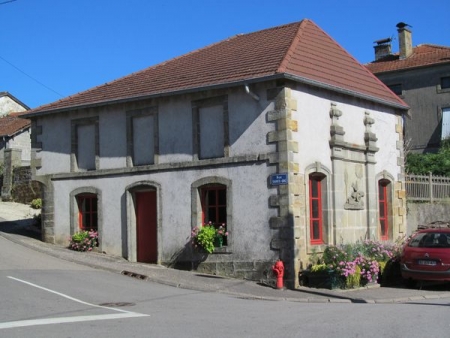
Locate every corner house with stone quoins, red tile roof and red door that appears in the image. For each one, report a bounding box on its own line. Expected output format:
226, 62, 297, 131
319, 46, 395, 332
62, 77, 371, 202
26, 20, 408, 286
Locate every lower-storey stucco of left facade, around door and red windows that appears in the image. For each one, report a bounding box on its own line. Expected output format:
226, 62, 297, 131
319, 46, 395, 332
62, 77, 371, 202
54, 164, 276, 261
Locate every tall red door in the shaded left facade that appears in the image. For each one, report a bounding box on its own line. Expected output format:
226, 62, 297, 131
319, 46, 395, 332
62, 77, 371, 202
135, 191, 158, 263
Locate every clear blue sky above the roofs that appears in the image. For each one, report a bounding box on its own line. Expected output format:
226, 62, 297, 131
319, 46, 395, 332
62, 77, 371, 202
0, 0, 450, 108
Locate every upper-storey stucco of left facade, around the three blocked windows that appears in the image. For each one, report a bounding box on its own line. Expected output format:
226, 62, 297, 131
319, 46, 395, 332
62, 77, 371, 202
36, 87, 276, 175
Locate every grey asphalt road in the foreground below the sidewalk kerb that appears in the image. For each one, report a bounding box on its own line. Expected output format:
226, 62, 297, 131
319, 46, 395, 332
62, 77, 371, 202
0, 237, 450, 338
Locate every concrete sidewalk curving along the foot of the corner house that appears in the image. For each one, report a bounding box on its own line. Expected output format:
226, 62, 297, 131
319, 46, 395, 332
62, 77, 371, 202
0, 202, 450, 303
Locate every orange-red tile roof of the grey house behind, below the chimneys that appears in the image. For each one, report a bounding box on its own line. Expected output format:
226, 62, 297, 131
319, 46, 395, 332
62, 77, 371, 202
366, 44, 450, 74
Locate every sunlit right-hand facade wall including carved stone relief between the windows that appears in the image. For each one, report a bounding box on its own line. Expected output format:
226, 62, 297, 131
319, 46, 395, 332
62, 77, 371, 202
292, 86, 401, 244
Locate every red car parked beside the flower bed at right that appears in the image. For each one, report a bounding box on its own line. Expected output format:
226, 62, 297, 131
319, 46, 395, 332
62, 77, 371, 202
400, 228, 450, 281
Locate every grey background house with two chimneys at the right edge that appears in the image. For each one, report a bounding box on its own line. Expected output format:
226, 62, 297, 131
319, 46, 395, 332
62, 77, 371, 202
366, 23, 450, 153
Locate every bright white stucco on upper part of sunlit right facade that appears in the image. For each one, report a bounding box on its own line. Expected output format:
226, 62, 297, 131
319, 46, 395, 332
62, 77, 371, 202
293, 88, 400, 178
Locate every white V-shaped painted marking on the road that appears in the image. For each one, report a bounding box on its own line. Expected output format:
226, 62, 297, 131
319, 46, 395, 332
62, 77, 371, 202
0, 276, 149, 329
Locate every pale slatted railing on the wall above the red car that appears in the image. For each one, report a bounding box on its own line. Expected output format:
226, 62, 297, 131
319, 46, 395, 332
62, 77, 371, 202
405, 173, 450, 202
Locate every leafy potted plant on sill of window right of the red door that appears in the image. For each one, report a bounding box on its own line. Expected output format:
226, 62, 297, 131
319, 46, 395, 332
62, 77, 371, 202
191, 222, 228, 253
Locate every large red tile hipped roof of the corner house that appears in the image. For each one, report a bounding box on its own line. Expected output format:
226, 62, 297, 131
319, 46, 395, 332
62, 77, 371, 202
29, 19, 407, 115
